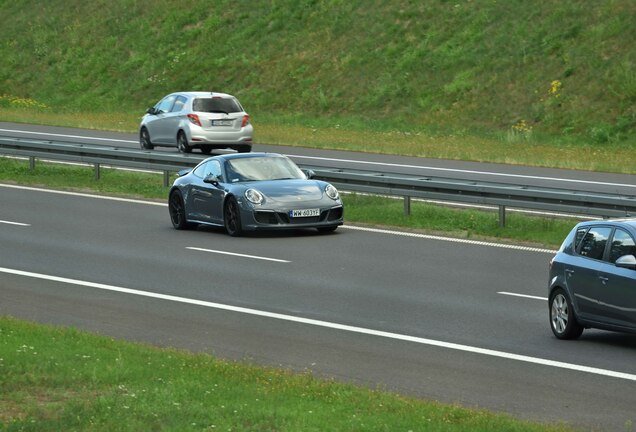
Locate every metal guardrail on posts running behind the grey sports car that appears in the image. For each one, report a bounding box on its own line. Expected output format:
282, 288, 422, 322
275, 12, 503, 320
0, 137, 636, 226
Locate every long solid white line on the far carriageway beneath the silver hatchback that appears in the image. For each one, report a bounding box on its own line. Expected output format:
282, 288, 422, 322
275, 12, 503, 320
0, 129, 636, 188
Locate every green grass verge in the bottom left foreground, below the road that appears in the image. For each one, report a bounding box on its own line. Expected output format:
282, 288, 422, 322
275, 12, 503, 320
0, 317, 571, 432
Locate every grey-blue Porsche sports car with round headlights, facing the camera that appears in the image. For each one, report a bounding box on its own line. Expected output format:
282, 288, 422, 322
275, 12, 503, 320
168, 153, 344, 236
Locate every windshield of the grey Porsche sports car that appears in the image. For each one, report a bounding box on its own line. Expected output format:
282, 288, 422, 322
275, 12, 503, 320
227, 156, 306, 182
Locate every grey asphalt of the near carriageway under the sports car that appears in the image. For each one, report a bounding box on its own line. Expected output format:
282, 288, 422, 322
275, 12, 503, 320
0, 185, 636, 430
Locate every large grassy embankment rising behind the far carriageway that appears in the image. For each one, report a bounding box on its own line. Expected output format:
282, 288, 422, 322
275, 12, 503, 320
0, 0, 636, 173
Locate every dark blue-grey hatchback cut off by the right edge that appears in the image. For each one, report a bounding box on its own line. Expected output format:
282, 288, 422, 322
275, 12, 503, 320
548, 219, 636, 339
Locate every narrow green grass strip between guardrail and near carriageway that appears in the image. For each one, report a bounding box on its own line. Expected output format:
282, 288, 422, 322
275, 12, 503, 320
0, 158, 576, 248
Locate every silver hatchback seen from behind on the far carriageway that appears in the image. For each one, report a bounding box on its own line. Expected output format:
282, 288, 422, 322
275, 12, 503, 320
139, 92, 253, 154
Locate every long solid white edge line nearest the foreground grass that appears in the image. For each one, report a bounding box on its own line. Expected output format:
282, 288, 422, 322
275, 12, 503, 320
0, 267, 636, 381
